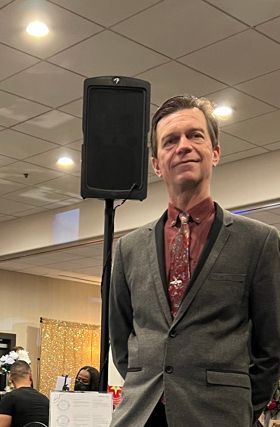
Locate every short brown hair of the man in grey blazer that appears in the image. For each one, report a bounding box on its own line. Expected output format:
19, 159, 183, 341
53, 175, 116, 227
151, 95, 219, 158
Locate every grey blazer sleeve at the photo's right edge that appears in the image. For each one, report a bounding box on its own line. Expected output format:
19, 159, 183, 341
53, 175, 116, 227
250, 227, 280, 420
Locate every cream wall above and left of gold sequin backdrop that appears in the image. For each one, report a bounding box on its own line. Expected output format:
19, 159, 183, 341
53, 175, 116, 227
0, 270, 101, 386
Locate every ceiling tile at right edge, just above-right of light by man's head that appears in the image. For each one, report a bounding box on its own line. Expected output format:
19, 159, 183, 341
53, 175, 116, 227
236, 70, 280, 108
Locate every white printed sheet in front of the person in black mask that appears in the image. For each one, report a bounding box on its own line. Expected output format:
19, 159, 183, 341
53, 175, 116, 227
49, 391, 113, 427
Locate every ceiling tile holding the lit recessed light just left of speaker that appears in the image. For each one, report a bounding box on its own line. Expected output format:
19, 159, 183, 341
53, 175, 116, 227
23, 147, 81, 174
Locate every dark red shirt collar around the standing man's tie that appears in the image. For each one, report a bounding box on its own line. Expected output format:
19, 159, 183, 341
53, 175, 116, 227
167, 197, 215, 227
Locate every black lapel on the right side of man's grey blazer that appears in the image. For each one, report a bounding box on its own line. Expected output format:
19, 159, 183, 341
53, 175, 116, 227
173, 205, 232, 325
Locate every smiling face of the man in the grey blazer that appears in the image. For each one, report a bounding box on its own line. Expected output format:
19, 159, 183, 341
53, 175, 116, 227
152, 108, 220, 194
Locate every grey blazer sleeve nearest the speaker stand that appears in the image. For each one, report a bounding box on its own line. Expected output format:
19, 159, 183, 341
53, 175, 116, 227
109, 239, 133, 378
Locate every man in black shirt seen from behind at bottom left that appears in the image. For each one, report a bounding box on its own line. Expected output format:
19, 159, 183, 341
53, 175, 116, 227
0, 360, 49, 427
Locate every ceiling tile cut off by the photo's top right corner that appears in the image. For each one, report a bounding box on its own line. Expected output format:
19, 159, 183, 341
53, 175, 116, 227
208, 0, 280, 26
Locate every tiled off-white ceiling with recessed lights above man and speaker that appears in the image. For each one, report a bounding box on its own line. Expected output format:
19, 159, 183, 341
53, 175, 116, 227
0, 0, 280, 281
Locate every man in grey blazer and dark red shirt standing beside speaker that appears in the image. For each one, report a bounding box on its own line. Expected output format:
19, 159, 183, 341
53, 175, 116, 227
110, 96, 280, 427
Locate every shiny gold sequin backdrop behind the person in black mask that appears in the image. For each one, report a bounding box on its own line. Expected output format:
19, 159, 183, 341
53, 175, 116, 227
39, 319, 100, 396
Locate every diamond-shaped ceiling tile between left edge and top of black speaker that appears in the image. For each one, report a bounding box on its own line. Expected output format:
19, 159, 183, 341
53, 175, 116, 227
0, 62, 83, 108
